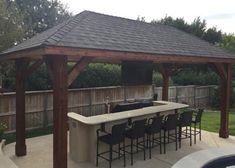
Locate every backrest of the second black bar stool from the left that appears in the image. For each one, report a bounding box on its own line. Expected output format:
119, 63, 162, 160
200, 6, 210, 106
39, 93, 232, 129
132, 119, 146, 138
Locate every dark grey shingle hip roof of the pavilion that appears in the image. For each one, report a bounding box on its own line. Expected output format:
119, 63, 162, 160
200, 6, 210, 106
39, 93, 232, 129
3, 11, 235, 58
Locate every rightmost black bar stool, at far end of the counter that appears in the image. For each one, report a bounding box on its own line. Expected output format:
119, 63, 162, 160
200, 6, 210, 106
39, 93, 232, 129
192, 109, 204, 144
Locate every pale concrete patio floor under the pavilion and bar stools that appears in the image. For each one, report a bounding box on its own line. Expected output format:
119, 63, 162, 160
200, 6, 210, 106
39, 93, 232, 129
3, 131, 235, 168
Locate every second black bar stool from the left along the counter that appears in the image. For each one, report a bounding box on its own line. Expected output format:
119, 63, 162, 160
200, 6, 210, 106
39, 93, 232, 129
126, 119, 146, 165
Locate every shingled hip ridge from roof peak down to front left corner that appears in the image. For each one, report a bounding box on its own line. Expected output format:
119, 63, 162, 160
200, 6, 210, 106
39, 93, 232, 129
42, 11, 89, 45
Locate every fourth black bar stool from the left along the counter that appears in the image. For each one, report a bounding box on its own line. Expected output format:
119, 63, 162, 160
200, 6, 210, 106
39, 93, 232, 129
162, 113, 178, 154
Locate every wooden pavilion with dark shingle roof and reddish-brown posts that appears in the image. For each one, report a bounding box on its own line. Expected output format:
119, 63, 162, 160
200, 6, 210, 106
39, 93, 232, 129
0, 11, 235, 168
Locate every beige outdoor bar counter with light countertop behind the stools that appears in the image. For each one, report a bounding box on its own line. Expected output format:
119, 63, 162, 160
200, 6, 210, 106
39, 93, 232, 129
68, 101, 188, 163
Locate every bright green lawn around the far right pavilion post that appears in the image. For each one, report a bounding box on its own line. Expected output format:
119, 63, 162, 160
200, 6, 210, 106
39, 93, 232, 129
202, 112, 235, 135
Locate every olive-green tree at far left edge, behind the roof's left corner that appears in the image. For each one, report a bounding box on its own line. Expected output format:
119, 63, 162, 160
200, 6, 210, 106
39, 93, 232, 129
0, 0, 24, 90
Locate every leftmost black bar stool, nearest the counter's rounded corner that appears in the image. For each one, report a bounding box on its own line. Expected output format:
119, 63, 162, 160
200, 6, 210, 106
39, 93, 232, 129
96, 123, 127, 168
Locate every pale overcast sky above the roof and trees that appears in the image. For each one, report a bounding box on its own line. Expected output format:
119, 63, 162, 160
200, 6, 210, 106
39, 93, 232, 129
60, 0, 235, 34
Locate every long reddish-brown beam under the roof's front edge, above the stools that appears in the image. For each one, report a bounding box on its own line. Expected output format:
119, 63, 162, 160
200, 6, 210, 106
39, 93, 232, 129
45, 47, 235, 64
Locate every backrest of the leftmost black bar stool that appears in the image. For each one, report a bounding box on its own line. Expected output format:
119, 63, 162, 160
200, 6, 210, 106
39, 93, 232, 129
112, 123, 127, 144
